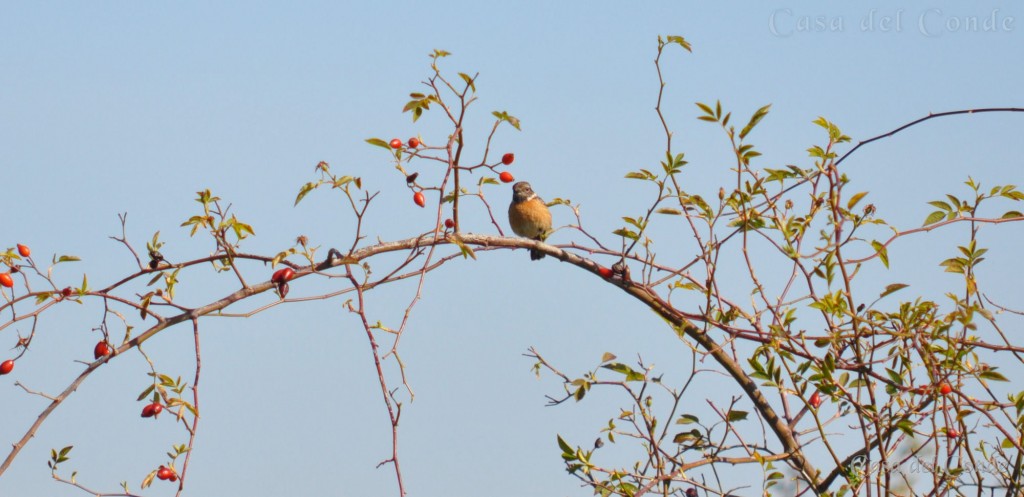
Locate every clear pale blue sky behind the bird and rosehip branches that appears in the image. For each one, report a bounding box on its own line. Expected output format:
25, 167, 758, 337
0, 1, 1024, 496
